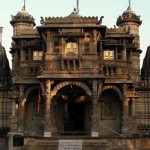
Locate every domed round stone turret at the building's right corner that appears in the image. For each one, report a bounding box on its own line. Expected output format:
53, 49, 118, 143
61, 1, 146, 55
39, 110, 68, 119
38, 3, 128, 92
116, 1, 142, 82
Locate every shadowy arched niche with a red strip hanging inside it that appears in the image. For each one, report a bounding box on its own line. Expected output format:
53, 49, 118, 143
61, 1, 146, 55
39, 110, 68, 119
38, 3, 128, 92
24, 86, 45, 135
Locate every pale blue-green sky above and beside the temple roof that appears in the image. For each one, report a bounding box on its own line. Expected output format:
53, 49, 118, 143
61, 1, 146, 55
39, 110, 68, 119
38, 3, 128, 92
0, 0, 150, 66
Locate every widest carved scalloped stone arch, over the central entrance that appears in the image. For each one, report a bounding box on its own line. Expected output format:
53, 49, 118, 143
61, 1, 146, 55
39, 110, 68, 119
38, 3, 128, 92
52, 81, 92, 95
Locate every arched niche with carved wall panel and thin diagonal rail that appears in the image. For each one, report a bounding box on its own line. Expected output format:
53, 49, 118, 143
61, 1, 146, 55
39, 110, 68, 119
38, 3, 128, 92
98, 86, 123, 136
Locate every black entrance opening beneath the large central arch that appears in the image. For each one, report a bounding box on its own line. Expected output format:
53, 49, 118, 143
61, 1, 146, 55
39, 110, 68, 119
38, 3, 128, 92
57, 85, 87, 132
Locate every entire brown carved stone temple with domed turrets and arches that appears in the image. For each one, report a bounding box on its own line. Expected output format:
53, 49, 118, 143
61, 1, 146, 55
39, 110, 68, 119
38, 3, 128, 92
0, 2, 150, 150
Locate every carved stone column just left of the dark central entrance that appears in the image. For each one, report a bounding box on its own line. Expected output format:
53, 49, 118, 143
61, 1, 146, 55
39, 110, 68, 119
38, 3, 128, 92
44, 80, 54, 137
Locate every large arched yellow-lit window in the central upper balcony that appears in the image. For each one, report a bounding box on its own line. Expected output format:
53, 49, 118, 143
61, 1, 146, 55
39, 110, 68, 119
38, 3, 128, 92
65, 42, 78, 55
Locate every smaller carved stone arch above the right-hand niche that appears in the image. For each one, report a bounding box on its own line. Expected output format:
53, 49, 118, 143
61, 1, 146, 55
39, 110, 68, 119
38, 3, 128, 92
101, 85, 123, 100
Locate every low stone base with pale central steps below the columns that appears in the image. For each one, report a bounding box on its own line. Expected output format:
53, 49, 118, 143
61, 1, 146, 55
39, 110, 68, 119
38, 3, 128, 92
9, 137, 150, 150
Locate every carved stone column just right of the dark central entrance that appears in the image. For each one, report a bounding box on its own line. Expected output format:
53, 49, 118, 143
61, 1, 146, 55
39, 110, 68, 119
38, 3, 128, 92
91, 80, 102, 137
